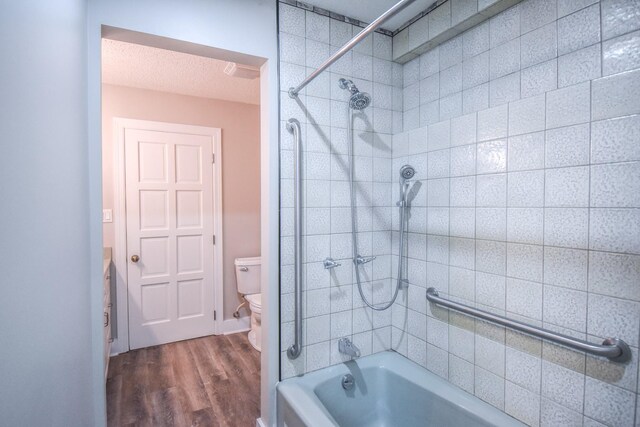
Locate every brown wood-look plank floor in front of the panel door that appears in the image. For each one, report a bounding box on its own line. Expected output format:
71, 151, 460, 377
107, 333, 260, 427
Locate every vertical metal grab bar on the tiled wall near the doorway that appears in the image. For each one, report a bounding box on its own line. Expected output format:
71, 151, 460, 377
287, 119, 302, 359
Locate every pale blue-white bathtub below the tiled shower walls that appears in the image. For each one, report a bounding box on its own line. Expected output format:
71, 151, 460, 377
277, 351, 524, 427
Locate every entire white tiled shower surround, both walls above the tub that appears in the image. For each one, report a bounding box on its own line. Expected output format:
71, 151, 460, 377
280, 0, 640, 426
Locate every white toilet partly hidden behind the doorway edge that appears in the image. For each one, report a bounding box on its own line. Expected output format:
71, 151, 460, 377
235, 257, 262, 351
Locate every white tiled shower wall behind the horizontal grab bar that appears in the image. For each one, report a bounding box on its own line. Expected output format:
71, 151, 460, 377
392, 0, 640, 426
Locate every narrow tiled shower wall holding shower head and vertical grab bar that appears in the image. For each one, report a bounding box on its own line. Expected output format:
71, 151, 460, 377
279, 3, 402, 378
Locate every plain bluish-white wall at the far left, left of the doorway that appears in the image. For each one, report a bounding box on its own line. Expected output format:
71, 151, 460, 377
0, 0, 95, 426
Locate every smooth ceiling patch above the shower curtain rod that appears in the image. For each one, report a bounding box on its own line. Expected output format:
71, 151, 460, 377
305, 0, 436, 31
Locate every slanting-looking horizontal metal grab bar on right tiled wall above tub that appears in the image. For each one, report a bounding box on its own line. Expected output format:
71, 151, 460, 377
427, 288, 631, 363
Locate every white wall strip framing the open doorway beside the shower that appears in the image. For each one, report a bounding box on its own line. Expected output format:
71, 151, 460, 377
87, 0, 278, 424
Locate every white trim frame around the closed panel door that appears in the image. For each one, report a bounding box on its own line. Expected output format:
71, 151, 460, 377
111, 117, 224, 354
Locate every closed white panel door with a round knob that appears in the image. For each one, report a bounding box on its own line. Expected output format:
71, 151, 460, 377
125, 129, 215, 349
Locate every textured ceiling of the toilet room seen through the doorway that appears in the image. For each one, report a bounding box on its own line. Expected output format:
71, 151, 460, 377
102, 39, 260, 105
